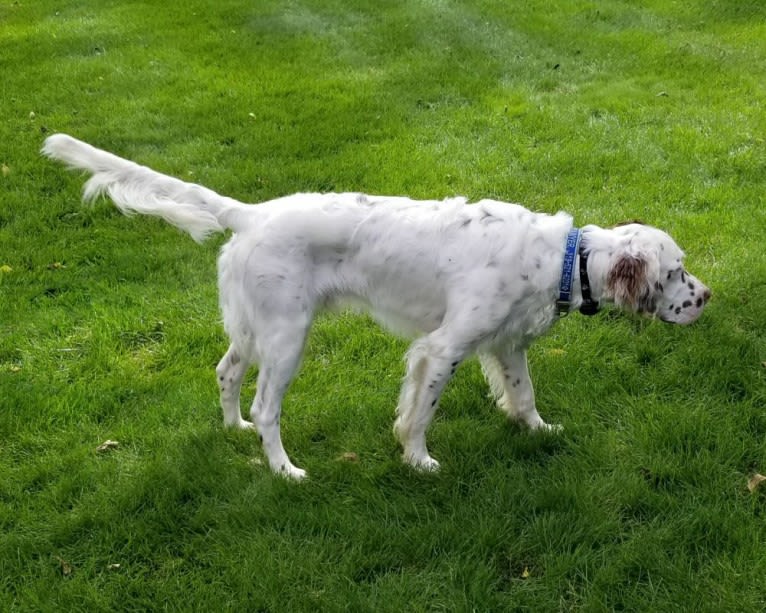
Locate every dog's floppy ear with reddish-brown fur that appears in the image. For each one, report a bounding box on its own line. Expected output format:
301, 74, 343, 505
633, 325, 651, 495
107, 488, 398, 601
606, 250, 660, 311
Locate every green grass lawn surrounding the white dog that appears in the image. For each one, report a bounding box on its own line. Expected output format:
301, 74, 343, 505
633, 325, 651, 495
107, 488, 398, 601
0, 0, 766, 611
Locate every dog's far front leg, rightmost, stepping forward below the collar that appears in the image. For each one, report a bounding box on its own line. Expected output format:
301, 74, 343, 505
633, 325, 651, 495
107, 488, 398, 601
480, 347, 560, 430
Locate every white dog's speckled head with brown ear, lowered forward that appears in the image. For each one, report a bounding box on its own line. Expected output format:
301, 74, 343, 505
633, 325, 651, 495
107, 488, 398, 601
604, 223, 710, 324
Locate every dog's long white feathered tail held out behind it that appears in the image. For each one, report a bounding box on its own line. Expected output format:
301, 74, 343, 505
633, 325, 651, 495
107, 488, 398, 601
42, 134, 250, 242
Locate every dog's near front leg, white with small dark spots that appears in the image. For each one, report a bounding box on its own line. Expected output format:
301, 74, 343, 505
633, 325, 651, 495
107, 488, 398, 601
394, 334, 463, 471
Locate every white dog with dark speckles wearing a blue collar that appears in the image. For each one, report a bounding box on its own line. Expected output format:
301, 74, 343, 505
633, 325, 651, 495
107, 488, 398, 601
43, 134, 710, 479
